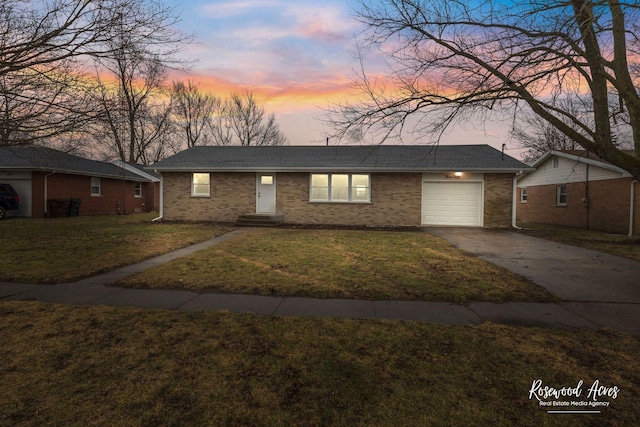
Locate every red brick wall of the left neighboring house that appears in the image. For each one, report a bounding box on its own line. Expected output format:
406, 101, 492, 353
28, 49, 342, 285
32, 172, 159, 218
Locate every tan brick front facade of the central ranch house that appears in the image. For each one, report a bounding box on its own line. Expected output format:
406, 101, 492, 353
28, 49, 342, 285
163, 172, 513, 227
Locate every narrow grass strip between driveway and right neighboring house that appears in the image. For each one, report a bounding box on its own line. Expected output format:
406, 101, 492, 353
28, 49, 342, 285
519, 224, 640, 261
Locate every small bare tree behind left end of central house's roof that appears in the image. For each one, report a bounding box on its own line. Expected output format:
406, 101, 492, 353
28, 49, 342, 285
171, 80, 221, 147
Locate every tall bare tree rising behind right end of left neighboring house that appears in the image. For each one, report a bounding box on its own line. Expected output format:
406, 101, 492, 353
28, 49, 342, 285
90, 0, 190, 163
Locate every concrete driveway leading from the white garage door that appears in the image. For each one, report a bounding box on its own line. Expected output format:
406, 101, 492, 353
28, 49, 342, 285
425, 227, 640, 333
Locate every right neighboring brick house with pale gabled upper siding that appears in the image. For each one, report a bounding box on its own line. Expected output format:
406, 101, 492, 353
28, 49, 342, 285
516, 151, 640, 235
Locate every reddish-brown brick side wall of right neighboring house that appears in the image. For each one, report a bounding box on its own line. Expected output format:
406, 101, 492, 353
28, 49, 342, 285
517, 178, 640, 234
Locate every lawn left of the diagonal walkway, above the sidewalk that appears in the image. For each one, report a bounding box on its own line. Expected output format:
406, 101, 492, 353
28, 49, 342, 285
0, 214, 231, 283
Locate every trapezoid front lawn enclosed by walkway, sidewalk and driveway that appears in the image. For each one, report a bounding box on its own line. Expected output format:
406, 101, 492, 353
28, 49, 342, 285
118, 229, 553, 303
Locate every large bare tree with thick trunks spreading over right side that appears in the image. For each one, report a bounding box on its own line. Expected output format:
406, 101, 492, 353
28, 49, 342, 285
328, 0, 640, 177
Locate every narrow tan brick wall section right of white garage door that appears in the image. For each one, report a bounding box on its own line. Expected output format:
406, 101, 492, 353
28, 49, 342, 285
484, 173, 513, 228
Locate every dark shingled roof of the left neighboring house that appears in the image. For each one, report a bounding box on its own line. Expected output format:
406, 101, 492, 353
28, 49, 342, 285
0, 147, 147, 181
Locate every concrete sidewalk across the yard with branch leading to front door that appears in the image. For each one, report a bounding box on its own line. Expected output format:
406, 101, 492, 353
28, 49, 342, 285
0, 229, 640, 334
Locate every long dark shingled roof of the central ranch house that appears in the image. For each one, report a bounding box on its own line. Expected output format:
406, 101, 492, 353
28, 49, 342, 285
148, 145, 533, 172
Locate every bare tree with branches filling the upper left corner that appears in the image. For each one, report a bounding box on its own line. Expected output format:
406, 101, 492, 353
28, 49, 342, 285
0, 0, 125, 145
